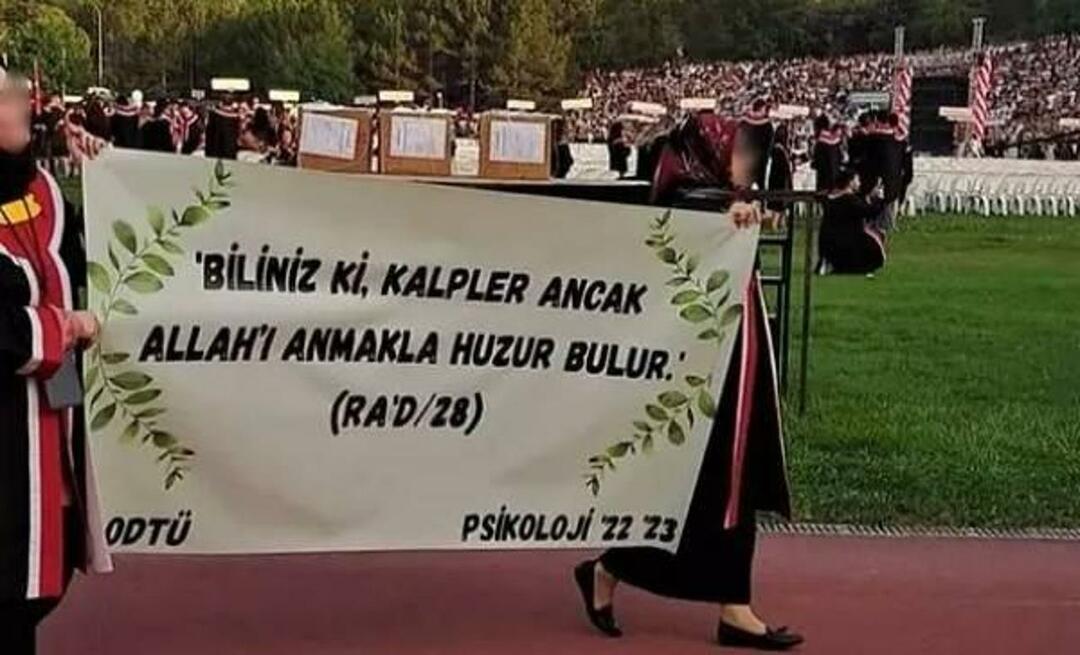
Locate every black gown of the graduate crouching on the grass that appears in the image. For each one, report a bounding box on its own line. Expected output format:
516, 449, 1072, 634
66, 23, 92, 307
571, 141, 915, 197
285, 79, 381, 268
818, 193, 886, 275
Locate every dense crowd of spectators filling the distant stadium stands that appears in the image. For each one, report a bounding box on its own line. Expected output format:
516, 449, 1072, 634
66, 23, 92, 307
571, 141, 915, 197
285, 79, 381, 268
583, 35, 1080, 155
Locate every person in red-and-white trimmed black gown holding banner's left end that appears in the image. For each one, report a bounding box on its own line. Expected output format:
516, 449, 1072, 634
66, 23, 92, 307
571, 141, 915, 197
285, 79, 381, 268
0, 69, 110, 655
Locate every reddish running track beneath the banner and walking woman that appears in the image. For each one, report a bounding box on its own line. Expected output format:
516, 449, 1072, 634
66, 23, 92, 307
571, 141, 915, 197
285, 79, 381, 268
42, 537, 1080, 655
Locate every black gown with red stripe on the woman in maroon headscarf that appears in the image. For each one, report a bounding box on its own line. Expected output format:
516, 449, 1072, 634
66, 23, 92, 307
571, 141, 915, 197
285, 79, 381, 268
600, 273, 791, 604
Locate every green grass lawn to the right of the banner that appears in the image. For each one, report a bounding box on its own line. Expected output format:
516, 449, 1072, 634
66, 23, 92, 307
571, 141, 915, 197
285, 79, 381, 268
787, 216, 1080, 526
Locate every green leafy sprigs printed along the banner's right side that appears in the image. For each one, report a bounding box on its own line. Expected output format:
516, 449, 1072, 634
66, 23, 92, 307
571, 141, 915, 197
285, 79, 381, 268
584, 210, 743, 496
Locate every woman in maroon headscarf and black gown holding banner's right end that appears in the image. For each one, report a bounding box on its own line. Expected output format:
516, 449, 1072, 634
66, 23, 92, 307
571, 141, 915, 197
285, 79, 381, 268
575, 112, 804, 651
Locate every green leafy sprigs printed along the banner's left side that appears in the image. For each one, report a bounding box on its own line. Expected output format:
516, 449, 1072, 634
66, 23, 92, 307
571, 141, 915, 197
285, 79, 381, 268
85, 161, 234, 490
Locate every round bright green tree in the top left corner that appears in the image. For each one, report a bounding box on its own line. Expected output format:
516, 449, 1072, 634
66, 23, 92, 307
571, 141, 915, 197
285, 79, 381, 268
0, 2, 91, 91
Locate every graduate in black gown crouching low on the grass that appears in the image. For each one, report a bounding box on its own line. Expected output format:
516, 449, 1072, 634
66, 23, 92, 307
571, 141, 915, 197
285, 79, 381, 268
818, 169, 886, 275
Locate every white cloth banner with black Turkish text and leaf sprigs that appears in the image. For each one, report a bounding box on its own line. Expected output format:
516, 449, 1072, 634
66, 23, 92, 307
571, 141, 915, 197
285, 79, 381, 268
85, 151, 757, 553
